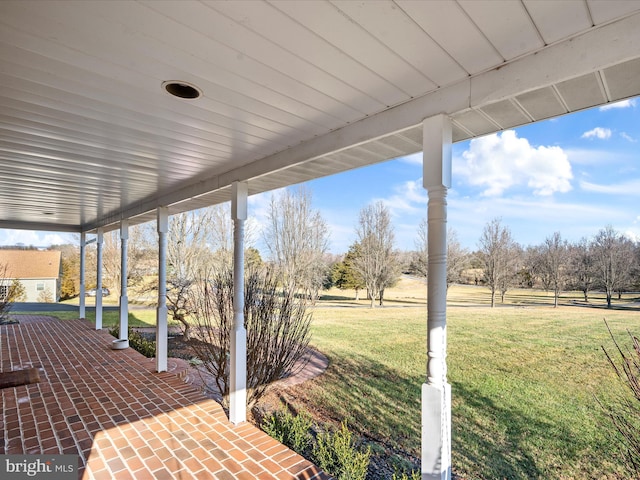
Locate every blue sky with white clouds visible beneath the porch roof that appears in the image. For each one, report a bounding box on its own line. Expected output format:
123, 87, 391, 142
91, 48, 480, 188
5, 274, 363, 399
0, 99, 640, 253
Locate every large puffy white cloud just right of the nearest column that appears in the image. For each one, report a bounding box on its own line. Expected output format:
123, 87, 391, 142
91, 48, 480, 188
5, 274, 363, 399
453, 130, 573, 196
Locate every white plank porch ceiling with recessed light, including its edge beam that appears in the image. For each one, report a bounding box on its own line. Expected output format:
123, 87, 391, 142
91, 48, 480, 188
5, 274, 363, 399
0, 0, 640, 231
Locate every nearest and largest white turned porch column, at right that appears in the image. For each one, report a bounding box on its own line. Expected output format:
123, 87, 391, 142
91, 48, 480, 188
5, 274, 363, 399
422, 115, 452, 480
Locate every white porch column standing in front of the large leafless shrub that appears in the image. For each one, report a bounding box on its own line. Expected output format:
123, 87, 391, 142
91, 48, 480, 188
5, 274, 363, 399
229, 182, 249, 424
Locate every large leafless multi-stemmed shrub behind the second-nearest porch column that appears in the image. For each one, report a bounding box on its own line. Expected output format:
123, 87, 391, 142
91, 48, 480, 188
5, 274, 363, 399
192, 268, 311, 405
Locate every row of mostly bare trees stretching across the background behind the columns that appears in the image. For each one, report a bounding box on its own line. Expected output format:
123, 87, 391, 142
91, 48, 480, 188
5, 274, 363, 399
36, 187, 640, 310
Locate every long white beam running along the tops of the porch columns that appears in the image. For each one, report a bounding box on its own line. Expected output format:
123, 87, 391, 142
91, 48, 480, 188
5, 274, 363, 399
82, 13, 640, 231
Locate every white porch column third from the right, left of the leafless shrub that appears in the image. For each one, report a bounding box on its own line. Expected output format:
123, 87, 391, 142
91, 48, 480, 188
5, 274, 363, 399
156, 207, 169, 372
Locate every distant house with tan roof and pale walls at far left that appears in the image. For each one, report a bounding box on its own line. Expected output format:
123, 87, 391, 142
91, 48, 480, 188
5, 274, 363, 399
0, 249, 62, 302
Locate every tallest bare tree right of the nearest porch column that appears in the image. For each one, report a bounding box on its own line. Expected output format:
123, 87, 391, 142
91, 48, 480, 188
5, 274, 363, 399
478, 219, 519, 307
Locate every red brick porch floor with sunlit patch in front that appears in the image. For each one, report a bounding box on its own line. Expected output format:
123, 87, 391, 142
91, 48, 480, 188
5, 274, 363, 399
0, 315, 329, 480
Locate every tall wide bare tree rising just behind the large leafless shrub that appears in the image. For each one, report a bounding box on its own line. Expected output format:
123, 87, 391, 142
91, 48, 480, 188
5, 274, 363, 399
264, 187, 329, 299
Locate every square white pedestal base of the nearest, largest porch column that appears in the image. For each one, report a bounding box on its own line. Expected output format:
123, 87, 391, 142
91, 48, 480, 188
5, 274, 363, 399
422, 383, 451, 480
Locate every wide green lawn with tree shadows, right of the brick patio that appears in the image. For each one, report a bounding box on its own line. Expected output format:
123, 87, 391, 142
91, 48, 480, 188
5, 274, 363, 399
302, 287, 640, 479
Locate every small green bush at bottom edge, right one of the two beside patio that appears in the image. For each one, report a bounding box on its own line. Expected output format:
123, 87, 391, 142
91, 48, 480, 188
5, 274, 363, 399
313, 422, 371, 480
